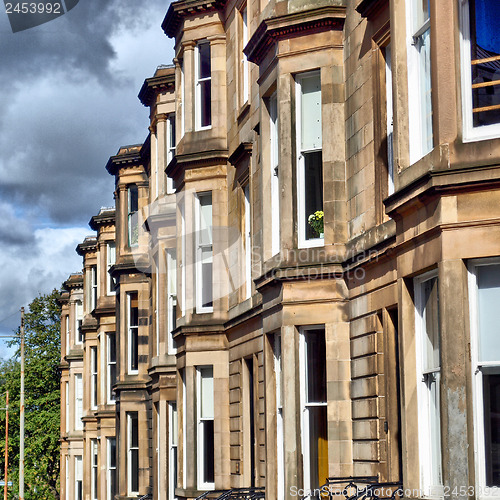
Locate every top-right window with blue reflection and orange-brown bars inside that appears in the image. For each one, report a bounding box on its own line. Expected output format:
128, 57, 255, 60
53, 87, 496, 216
461, 0, 500, 140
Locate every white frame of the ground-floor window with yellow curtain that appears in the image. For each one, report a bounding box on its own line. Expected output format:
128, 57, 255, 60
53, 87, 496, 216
299, 325, 328, 491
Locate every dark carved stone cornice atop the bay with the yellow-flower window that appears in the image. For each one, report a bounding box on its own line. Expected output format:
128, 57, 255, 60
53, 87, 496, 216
244, 6, 346, 64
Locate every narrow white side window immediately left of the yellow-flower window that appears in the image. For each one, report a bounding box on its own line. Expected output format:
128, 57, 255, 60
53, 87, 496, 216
269, 92, 280, 255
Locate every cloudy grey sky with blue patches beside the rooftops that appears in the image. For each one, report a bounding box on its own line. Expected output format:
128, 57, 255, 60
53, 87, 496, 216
0, 0, 173, 356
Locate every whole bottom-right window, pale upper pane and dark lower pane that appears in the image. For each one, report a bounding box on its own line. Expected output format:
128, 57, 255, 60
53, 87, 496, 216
469, 260, 500, 492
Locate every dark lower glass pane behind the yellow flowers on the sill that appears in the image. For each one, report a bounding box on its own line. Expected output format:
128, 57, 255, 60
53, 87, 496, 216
304, 151, 323, 240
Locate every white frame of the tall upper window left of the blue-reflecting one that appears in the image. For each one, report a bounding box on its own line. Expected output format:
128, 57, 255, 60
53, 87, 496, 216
406, 0, 434, 164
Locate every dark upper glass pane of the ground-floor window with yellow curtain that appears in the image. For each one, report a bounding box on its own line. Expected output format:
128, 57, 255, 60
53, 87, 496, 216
305, 330, 326, 403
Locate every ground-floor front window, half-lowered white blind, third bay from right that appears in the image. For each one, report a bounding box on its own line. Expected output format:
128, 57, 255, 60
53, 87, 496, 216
196, 366, 215, 490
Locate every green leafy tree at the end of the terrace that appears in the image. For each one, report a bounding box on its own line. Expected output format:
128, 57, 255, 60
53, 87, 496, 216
0, 290, 61, 500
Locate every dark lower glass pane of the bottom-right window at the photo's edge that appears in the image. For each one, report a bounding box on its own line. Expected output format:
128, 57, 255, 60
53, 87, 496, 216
483, 369, 500, 487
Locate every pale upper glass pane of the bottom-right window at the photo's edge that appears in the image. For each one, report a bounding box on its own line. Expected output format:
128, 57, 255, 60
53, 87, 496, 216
477, 265, 500, 362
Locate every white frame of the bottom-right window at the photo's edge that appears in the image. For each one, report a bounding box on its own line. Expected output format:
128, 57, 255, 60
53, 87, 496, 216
468, 258, 500, 499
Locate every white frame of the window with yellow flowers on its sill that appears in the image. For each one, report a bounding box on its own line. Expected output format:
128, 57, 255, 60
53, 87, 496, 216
295, 70, 325, 248
